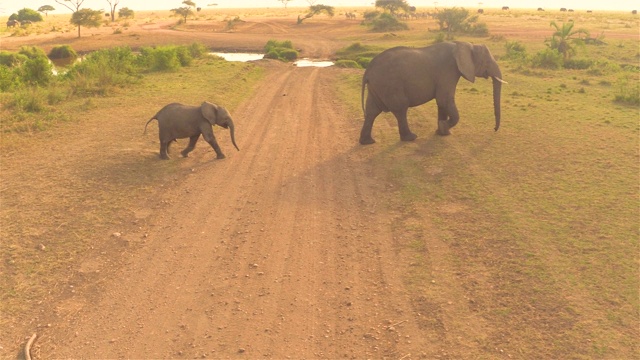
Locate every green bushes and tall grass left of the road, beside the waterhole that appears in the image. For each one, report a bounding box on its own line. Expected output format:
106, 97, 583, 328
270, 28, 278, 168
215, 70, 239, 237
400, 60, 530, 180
0, 43, 214, 133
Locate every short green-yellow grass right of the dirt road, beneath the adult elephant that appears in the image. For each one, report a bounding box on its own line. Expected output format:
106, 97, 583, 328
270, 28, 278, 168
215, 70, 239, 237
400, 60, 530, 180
338, 38, 640, 358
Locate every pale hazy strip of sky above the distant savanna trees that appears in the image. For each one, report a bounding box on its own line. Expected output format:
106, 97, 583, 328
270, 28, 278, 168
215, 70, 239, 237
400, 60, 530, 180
0, 0, 640, 16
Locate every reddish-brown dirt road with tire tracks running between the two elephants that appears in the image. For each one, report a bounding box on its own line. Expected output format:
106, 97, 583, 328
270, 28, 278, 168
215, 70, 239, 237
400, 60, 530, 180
41, 65, 433, 358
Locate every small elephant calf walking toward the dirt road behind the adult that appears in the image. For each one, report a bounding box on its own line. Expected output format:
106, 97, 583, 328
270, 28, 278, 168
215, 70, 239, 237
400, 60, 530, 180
144, 101, 240, 160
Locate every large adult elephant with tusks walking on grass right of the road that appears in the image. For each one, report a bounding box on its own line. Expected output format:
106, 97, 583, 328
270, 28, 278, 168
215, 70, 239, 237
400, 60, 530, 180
360, 42, 504, 145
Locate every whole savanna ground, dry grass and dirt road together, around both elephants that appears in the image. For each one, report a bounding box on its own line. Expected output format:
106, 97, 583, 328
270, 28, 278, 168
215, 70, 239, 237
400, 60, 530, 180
0, 8, 640, 359
